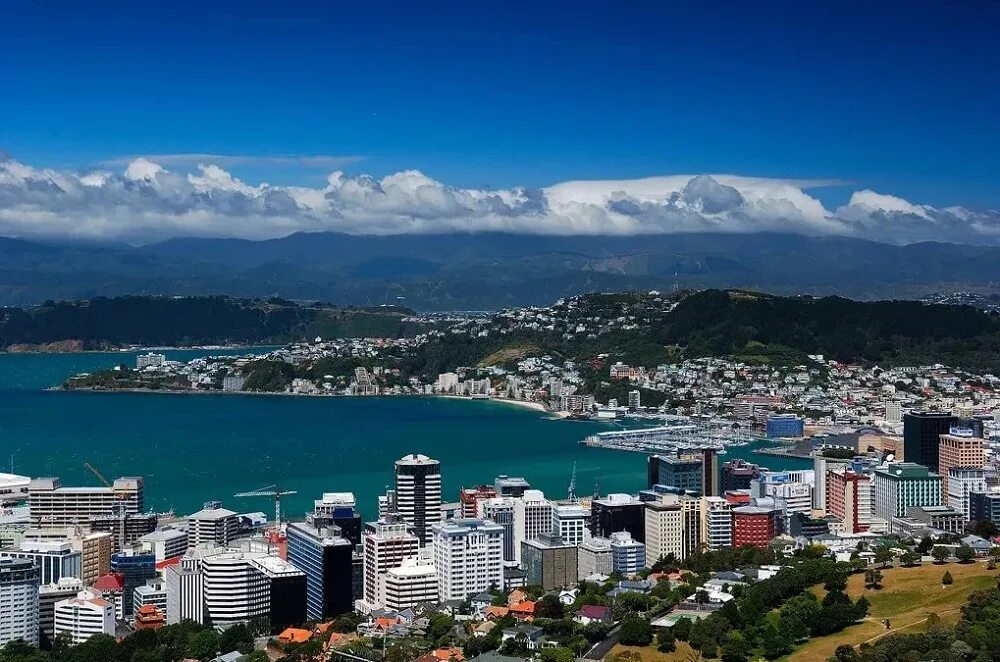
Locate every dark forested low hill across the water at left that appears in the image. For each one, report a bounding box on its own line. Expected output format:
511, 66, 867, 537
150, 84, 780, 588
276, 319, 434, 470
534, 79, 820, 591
0, 296, 420, 349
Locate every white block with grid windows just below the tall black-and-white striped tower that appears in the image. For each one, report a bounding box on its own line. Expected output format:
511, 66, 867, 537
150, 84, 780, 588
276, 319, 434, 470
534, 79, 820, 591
432, 519, 503, 601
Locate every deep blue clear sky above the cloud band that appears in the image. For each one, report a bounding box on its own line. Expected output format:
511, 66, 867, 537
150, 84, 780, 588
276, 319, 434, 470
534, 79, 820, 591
0, 2, 1000, 207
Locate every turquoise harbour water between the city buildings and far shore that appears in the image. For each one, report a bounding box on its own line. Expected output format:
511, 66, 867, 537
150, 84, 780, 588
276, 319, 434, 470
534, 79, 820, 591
0, 350, 808, 517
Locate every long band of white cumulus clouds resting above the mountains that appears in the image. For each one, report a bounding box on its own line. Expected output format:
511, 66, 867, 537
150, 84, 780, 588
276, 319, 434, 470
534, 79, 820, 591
0, 155, 1000, 243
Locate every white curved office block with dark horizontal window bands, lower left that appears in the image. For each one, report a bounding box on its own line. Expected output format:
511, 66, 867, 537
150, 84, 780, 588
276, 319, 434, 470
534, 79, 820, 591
201, 552, 270, 631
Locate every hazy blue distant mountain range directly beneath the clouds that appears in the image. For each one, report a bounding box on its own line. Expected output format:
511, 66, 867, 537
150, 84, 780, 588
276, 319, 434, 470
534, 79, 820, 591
0, 233, 1000, 310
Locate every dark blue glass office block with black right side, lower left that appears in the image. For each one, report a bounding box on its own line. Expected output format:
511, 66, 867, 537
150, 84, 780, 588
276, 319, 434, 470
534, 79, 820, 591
287, 516, 354, 620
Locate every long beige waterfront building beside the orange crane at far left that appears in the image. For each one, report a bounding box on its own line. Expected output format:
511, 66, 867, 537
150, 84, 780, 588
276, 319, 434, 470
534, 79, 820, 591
28, 477, 143, 529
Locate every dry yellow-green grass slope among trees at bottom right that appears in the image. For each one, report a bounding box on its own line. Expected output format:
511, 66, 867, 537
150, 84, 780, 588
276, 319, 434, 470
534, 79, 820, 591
612, 562, 1000, 662
